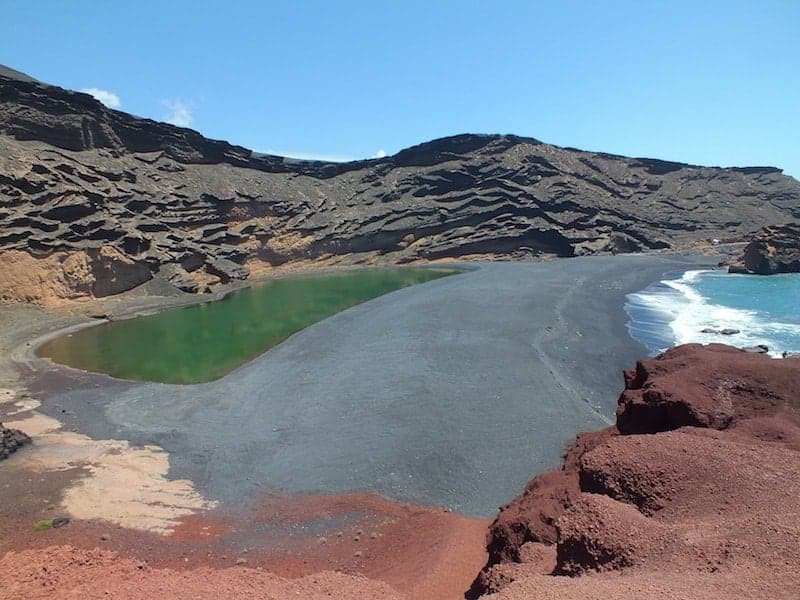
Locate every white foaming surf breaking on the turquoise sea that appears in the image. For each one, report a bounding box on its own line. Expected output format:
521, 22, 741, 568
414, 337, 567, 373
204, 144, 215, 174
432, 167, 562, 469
628, 270, 800, 356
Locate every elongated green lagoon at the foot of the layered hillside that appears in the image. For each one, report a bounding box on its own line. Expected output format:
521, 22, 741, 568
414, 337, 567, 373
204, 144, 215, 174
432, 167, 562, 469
39, 269, 457, 384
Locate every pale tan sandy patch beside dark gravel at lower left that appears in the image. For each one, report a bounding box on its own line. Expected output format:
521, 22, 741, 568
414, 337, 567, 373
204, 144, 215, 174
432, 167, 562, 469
4, 401, 216, 534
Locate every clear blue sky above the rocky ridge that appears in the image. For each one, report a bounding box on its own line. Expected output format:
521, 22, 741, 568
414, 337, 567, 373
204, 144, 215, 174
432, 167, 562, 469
0, 0, 800, 177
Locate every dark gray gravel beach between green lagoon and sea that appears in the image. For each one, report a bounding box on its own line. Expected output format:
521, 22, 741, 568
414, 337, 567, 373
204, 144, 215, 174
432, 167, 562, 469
28, 256, 712, 516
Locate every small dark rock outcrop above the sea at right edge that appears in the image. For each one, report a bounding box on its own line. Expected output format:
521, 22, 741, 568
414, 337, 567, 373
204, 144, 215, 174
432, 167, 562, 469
729, 223, 800, 275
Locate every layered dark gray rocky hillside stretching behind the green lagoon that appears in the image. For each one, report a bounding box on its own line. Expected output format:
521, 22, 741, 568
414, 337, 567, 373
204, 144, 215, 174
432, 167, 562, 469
0, 70, 800, 302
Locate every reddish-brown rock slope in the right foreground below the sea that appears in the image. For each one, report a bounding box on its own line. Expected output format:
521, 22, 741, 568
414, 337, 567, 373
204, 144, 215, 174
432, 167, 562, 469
471, 344, 800, 600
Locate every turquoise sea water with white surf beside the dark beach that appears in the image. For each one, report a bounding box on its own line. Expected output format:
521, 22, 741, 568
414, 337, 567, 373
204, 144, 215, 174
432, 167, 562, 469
625, 270, 800, 356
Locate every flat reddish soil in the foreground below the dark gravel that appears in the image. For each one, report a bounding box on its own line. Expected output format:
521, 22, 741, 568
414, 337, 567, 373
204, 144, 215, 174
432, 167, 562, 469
0, 486, 488, 600
